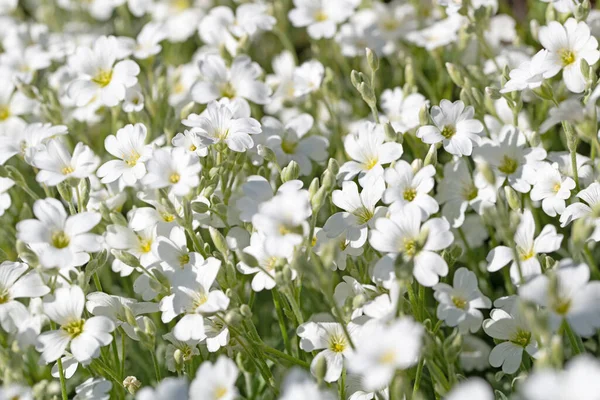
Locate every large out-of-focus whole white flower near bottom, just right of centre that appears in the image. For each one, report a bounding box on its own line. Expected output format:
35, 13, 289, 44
348, 318, 423, 390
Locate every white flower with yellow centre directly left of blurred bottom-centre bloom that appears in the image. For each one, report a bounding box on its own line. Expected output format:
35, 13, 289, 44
297, 316, 352, 382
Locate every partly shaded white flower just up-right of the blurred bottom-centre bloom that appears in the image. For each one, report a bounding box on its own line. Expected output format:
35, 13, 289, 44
433, 268, 492, 334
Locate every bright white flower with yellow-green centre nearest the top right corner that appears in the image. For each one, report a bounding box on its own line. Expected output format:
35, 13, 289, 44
539, 18, 600, 93
